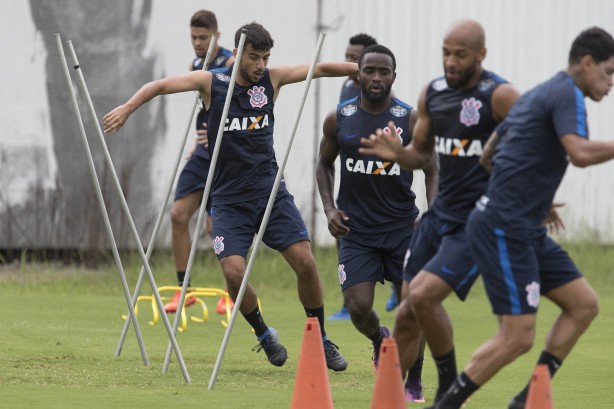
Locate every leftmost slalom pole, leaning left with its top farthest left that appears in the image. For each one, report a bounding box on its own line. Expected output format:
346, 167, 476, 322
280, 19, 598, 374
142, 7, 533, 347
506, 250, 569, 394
55, 34, 149, 366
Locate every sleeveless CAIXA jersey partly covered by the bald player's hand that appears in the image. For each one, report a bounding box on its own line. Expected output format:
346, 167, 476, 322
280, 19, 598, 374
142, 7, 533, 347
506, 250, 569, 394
336, 97, 418, 233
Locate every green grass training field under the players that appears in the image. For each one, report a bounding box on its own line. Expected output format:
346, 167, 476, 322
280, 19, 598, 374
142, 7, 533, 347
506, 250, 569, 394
0, 244, 614, 409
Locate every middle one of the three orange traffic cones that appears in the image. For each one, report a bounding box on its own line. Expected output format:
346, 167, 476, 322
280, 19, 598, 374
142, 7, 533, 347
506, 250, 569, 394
371, 338, 407, 409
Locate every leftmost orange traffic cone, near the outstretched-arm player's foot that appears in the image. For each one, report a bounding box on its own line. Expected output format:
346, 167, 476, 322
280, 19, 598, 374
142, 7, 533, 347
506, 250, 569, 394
290, 317, 334, 409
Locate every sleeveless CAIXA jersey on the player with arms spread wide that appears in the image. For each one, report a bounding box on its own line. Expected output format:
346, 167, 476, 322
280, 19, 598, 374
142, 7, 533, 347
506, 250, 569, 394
208, 68, 285, 204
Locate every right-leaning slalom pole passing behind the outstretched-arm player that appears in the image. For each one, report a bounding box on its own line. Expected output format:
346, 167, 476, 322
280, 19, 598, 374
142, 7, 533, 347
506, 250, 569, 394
115, 35, 217, 356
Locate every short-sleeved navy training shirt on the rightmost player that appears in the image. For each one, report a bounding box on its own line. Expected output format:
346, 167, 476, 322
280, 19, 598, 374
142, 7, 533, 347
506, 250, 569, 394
478, 71, 588, 234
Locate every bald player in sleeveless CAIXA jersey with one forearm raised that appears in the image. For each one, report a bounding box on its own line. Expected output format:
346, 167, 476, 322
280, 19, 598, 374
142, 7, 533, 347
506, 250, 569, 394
363, 19, 518, 401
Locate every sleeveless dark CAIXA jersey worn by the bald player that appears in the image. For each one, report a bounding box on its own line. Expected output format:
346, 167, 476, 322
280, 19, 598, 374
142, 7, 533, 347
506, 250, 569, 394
426, 70, 507, 223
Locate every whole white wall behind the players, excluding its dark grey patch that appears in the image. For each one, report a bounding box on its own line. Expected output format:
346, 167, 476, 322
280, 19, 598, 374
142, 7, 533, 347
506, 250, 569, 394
0, 0, 614, 243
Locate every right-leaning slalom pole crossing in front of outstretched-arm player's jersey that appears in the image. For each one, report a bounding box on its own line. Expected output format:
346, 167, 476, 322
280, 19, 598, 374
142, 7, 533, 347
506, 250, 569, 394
162, 29, 247, 373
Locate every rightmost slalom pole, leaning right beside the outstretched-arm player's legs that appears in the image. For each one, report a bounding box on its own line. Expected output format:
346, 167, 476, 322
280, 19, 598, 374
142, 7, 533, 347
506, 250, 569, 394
209, 33, 325, 390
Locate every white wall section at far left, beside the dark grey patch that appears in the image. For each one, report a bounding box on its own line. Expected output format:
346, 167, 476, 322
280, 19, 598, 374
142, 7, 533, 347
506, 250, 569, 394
0, 0, 56, 201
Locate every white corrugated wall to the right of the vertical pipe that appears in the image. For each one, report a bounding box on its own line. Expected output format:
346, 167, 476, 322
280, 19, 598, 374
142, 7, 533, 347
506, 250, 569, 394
323, 0, 614, 241
